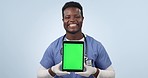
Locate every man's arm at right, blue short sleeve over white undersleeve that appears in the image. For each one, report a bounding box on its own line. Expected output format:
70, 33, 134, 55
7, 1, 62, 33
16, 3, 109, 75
95, 41, 115, 78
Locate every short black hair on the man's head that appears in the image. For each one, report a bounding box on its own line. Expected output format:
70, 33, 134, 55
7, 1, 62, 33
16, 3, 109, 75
62, 1, 83, 18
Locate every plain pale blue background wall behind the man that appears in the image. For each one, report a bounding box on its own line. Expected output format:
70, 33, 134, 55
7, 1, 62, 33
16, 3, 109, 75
0, 0, 148, 78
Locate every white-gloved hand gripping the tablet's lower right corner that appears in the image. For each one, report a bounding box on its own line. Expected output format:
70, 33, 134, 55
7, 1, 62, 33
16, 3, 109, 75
75, 64, 97, 77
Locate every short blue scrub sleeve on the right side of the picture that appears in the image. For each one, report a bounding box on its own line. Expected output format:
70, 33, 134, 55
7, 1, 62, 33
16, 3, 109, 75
95, 43, 112, 70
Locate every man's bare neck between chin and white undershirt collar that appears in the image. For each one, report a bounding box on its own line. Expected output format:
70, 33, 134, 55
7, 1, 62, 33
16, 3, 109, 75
66, 32, 83, 40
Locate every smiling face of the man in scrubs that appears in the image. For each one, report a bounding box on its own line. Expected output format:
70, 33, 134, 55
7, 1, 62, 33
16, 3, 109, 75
63, 7, 83, 34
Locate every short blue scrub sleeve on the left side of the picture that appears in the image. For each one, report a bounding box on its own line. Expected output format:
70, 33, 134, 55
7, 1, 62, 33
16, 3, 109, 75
40, 45, 54, 69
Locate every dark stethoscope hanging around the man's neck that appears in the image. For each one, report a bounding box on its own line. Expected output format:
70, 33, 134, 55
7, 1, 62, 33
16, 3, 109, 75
60, 33, 92, 66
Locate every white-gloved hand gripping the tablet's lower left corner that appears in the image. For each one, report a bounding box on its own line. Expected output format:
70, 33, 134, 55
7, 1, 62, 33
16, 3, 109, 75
51, 61, 70, 76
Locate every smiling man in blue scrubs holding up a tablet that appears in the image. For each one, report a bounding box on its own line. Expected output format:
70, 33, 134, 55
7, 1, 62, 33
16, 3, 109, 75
38, 1, 115, 78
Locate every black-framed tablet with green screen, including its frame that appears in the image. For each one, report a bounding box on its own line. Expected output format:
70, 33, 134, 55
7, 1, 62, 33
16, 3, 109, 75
62, 41, 84, 72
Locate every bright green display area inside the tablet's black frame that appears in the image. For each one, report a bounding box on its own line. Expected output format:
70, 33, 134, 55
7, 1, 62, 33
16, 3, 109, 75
63, 43, 83, 70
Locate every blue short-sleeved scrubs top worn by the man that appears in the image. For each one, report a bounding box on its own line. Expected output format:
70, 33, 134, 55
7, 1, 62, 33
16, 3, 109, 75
40, 35, 112, 78
